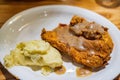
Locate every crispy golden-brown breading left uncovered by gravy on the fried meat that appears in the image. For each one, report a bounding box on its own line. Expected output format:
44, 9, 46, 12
41, 17, 113, 68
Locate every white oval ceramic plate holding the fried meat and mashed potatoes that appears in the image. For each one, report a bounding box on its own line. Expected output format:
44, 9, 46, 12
0, 5, 120, 80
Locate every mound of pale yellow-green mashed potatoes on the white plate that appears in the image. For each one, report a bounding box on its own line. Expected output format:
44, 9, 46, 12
4, 40, 63, 75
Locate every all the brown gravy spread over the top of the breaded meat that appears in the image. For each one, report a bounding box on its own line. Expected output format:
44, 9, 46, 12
54, 22, 107, 54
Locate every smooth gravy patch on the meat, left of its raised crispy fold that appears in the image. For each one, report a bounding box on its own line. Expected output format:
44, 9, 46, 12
54, 26, 85, 50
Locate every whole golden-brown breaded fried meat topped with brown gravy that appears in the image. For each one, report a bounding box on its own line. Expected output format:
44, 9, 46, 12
41, 16, 113, 68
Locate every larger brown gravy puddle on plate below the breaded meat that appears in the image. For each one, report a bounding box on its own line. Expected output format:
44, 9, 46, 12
76, 67, 92, 77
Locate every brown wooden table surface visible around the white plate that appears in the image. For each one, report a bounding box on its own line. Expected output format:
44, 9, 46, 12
0, 0, 120, 80
